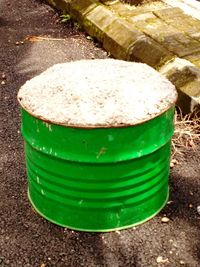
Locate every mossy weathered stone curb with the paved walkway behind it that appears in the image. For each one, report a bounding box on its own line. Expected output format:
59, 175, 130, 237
47, 0, 200, 112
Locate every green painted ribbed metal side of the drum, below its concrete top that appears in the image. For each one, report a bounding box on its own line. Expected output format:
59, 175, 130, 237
22, 106, 174, 231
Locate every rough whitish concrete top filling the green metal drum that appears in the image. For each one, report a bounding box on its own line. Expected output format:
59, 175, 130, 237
18, 59, 177, 128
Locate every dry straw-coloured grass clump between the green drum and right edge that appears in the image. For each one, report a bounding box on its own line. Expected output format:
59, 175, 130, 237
172, 108, 200, 158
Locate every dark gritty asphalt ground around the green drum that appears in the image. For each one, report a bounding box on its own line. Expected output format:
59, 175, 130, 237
0, 0, 200, 267
